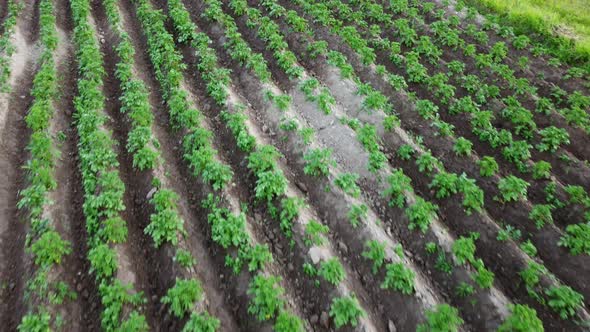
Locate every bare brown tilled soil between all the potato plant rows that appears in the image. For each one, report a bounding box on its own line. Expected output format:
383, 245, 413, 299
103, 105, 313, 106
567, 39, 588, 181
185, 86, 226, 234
0, 0, 590, 331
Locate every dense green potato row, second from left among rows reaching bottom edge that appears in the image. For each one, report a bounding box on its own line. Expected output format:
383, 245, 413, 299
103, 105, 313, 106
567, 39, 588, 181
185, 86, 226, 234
70, 0, 148, 331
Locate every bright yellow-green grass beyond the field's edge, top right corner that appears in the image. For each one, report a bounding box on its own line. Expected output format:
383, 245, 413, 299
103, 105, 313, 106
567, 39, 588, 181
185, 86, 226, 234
464, 0, 590, 67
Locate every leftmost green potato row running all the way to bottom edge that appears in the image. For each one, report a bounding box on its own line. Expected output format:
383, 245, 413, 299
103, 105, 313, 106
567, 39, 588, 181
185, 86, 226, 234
17, 0, 76, 331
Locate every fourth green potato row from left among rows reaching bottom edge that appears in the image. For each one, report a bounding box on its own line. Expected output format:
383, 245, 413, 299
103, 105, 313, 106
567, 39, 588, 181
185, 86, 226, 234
135, 0, 301, 328
